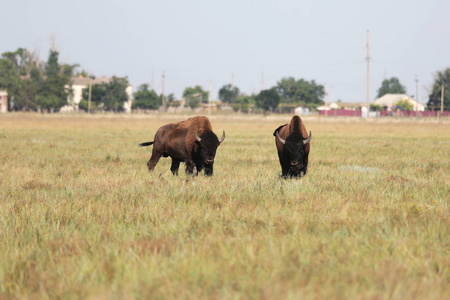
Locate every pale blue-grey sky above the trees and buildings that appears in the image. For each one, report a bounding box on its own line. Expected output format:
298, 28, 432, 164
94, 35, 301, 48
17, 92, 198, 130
0, 0, 450, 103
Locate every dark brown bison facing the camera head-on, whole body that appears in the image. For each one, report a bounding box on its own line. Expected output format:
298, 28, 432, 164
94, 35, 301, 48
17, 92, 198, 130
273, 116, 312, 178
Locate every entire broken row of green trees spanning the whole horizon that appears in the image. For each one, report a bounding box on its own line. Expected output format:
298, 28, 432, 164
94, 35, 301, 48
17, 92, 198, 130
0, 48, 450, 112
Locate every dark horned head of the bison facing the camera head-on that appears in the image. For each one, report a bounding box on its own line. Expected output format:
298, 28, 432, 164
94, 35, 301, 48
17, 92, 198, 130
276, 131, 312, 174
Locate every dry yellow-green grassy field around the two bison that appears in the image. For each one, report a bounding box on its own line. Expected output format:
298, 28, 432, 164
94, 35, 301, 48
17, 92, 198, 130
0, 114, 450, 299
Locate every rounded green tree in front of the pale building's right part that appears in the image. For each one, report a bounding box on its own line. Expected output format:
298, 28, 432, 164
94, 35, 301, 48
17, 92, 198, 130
101, 77, 128, 112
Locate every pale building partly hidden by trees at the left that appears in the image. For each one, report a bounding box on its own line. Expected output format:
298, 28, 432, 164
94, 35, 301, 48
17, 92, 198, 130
61, 76, 133, 112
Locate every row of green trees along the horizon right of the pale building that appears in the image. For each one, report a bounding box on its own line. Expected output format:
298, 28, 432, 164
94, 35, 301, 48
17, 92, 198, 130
102, 68, 450, 112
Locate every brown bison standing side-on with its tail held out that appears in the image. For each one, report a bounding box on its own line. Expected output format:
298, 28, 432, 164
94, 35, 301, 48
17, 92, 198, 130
139, 117, 225, 176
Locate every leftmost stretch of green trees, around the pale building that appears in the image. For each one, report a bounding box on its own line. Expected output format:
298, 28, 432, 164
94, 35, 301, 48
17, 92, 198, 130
0, 48, 128, 112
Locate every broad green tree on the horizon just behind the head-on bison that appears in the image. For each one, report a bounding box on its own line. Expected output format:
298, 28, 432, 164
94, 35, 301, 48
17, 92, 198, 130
276, 77, 325, 107
